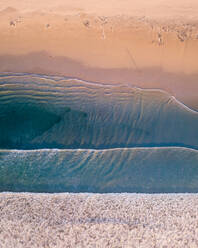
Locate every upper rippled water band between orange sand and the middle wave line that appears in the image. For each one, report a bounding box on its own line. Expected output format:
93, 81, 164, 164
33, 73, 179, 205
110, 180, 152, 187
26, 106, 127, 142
0, 75, 198, 149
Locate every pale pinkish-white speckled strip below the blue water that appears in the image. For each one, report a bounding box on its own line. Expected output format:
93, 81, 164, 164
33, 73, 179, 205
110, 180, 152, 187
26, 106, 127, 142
0, 193, 198, 248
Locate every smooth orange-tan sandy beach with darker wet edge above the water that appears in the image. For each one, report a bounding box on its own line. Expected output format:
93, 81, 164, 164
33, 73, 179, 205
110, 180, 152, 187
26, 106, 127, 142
0, 0, 198, 110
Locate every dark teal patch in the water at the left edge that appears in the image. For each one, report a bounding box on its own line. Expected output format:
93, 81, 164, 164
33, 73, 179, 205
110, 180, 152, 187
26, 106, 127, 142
0, 101, 61, 149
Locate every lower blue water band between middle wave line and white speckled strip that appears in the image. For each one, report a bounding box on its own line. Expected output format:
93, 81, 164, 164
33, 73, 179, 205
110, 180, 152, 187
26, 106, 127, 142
0, 147, 198, 193
